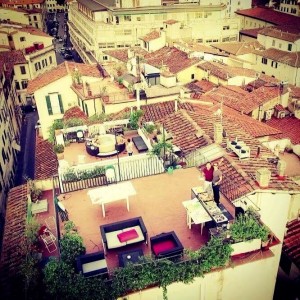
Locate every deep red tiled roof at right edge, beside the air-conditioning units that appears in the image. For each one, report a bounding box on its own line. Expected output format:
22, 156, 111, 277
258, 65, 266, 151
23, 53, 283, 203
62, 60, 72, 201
266, 116, 300, 145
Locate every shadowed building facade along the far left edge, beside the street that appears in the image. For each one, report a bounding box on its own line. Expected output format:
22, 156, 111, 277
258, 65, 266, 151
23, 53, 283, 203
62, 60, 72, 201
0, 52, 21, 248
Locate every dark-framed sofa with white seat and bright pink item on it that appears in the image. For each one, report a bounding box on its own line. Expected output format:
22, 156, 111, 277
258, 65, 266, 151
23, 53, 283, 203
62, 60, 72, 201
100, 217, 148, 251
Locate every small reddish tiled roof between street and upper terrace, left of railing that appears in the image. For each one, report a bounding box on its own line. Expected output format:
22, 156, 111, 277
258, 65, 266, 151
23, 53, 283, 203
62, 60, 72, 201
35, 137, 58, 180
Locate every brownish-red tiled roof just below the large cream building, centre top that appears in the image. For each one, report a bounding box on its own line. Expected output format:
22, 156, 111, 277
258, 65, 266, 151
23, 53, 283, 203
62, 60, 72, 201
144, 47, 199, 74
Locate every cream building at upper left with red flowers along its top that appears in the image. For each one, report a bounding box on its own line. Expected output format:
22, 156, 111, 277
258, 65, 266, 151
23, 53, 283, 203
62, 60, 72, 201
0, 23, 57, 103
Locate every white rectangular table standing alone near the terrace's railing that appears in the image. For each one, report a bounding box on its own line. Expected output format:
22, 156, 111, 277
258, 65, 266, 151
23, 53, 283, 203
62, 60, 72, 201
87, 181, 136, 218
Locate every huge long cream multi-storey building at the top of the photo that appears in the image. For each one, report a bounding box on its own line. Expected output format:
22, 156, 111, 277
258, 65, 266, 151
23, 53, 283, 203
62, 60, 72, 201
68, 0, 248, 63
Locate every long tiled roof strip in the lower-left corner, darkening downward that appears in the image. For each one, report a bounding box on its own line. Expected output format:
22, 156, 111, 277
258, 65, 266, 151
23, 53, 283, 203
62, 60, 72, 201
0, 184, 27, 283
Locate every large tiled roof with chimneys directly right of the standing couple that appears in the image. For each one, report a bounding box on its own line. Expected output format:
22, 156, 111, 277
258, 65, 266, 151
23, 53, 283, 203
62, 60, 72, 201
187, 105, 300, 201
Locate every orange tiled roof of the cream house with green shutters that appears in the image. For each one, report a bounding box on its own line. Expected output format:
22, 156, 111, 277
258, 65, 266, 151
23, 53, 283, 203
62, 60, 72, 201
27, 62, 102, 94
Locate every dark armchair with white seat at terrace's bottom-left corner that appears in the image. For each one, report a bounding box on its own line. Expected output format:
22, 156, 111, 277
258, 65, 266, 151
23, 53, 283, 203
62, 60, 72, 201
76, 251, 108, 277
